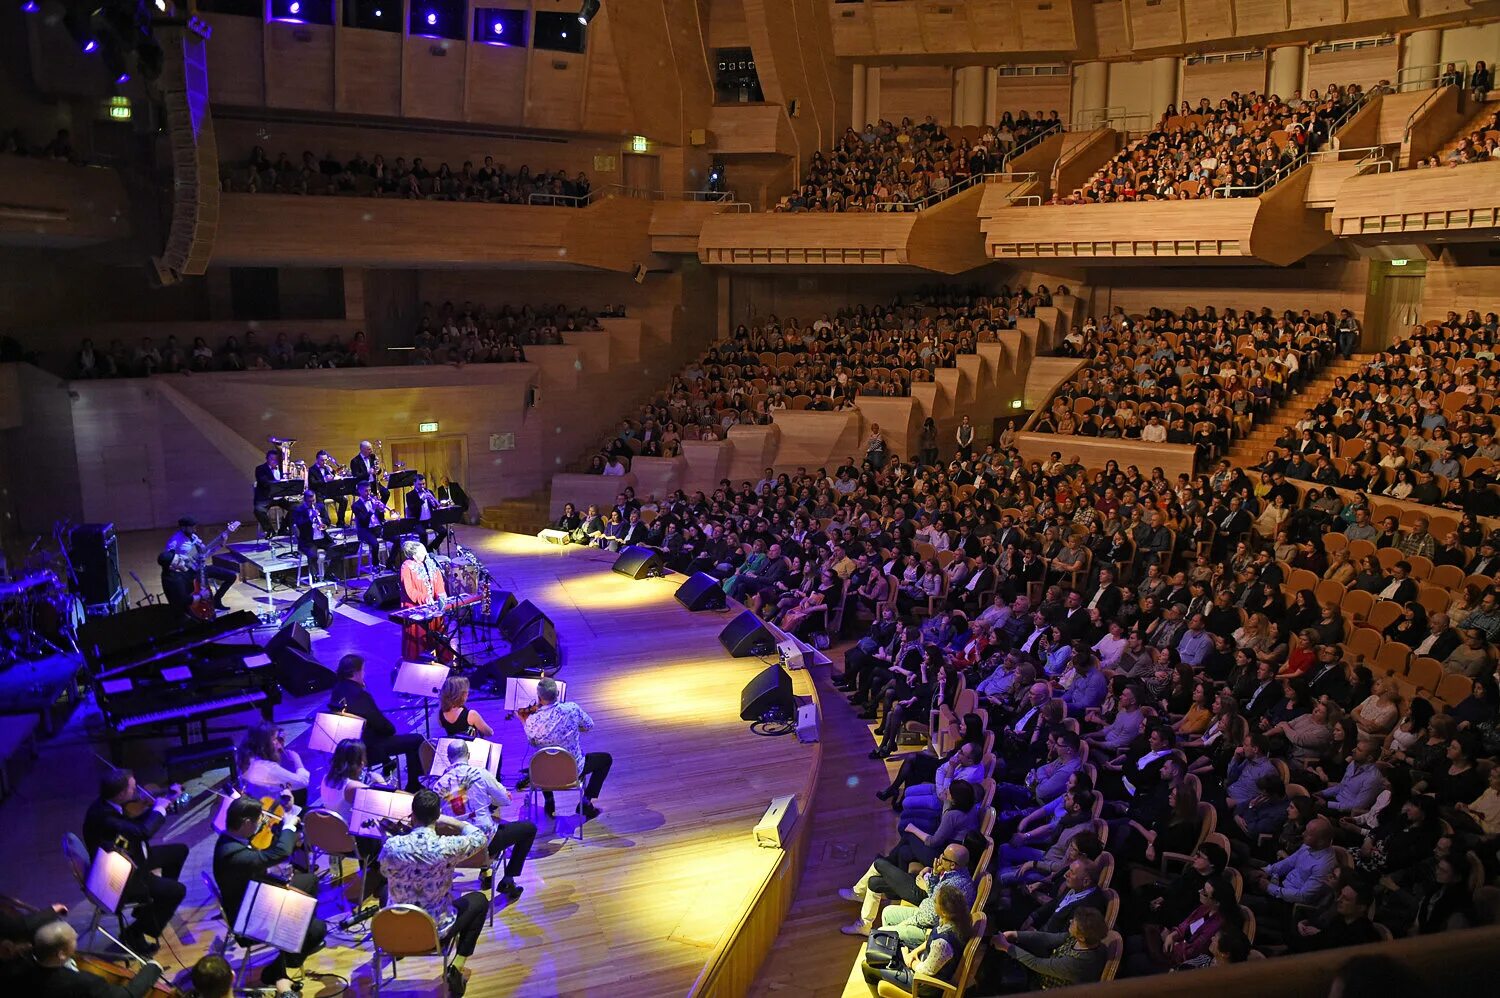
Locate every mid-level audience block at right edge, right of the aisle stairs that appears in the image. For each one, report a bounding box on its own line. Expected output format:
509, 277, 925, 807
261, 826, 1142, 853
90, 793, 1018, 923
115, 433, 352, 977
1257, 311, 1500, 516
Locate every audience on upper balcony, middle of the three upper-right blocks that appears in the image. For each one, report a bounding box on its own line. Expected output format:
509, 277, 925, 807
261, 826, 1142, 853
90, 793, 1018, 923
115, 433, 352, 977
1053, 84, 1364, 204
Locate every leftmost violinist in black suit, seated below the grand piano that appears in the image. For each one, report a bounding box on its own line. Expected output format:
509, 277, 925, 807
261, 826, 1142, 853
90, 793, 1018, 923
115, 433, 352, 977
84, 770, 188, 956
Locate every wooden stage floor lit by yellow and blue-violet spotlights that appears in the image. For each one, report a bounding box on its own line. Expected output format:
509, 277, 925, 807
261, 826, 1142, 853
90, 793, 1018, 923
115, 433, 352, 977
0, 530, 821, 998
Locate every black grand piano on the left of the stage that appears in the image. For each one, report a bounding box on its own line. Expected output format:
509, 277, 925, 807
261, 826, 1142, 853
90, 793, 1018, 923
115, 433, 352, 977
78, 605, 281, 744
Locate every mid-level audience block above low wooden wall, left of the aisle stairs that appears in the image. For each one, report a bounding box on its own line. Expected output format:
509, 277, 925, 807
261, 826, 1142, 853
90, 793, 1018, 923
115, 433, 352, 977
1034, 306, 1337, 461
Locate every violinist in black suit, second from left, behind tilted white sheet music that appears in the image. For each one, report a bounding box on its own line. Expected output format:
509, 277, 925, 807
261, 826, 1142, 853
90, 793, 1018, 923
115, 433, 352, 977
213, 797, 329, 987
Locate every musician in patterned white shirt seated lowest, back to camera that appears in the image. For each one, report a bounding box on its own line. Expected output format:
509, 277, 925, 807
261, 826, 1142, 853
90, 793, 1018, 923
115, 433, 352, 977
380, 789, 489, 998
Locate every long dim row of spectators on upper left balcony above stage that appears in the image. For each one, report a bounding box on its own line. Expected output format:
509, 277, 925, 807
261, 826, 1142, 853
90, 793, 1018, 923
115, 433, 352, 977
224, 146, 593, 207
